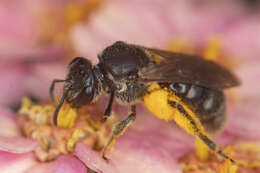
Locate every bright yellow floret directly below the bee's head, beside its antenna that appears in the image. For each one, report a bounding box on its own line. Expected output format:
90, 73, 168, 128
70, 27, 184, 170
57, 104, 77, 128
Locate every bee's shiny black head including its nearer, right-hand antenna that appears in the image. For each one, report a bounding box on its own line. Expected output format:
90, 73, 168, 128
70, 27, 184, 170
54, 57, 98, 124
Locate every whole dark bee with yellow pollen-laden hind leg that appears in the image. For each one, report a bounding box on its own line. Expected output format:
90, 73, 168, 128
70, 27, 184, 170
50, 41, 239, 162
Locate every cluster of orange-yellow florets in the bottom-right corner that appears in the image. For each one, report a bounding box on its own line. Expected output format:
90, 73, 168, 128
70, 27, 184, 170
180, 142, 260, 173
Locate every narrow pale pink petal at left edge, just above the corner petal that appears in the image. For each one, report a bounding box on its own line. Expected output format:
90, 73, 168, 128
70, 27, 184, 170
0, 136, 37, 153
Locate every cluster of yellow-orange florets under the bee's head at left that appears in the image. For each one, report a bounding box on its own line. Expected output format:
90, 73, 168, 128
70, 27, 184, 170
17, 98, 111, 162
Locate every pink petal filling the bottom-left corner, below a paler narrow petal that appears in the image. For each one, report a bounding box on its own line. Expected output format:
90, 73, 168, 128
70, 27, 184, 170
0, 151, 37, 173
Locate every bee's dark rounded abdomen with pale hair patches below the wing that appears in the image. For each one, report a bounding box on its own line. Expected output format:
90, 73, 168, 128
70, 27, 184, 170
161, 83, 226, 133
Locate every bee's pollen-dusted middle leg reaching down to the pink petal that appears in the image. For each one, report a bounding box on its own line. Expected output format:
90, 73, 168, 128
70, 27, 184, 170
102, 105, 136, 160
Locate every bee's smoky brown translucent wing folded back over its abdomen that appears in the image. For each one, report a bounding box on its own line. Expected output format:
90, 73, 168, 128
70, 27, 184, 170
135, 46, 240, 89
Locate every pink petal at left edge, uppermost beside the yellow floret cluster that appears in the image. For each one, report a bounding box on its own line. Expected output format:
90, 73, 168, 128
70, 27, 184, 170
0, 106, 20, 137
